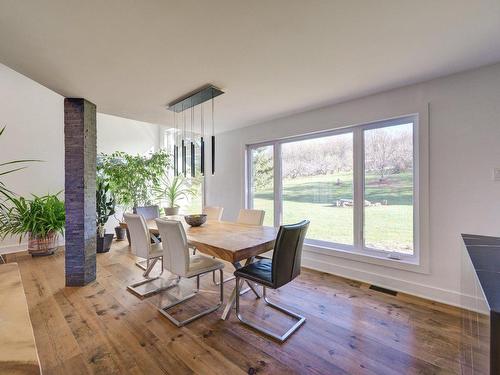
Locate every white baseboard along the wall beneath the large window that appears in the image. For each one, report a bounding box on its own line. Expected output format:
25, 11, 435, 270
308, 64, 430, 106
302, 251, 487, 313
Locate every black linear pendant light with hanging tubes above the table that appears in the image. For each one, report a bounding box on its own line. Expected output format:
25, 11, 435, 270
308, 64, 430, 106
168, 85, 224, 177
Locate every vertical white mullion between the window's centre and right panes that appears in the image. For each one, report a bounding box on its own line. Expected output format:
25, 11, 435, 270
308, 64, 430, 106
353, 128, 364, 250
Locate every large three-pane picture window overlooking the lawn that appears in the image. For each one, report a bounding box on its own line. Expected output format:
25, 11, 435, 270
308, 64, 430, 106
247, 116, 418, 259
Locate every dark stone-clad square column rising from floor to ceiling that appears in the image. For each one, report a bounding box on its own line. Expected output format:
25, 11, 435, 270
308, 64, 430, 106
64, 98, 97, 286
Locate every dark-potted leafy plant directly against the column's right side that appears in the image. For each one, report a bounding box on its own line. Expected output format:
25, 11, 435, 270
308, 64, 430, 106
96, 178, 115, 253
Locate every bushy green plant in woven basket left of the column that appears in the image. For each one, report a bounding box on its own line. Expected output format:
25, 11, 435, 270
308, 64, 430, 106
0, 194, 66, 256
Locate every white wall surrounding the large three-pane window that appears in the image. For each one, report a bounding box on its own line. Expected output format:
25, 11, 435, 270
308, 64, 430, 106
206, 64, 500, 312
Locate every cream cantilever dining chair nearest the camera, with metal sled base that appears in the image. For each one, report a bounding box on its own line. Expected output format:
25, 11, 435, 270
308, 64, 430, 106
155, 219, 224, 327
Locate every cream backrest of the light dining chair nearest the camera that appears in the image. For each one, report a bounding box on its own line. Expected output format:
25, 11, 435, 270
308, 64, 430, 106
155, 219, 189, 276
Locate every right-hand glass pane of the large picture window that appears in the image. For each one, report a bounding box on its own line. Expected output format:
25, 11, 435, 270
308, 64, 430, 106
363, 123, 413, 255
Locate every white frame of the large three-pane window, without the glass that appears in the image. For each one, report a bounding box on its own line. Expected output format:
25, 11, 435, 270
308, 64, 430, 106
245, 113, 427, 272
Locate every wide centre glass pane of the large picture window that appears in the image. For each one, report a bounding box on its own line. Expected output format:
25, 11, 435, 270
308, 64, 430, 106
281, 132, 354, 245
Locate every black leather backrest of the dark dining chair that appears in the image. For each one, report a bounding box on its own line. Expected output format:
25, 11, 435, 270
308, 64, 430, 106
272, 220, 309, 288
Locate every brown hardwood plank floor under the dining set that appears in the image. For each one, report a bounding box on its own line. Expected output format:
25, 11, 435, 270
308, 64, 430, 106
7, 242, 480, 375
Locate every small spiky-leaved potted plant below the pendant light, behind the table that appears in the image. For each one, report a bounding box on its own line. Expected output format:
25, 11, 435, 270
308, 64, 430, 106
155, 174, 196, 216
